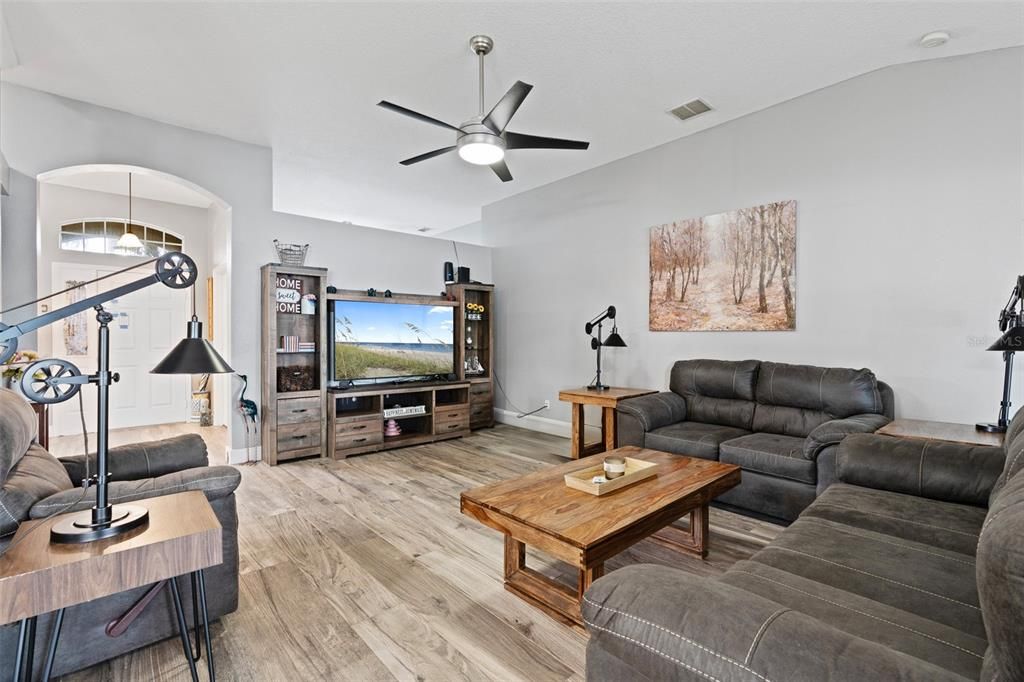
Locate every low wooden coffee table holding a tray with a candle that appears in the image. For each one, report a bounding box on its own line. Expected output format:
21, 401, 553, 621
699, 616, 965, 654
461, 446, 739, 625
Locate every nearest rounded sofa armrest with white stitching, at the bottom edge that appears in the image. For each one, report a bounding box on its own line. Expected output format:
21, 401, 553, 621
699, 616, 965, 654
582, 565, 963, 682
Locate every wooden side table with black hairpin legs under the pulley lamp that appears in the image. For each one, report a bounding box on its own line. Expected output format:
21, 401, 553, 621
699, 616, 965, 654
0, 491, 223, 682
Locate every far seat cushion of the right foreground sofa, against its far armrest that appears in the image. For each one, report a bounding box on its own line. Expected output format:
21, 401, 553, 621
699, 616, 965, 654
802, 483, 985, 557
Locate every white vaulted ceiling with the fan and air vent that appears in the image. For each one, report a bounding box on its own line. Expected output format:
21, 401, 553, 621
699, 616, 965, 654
3, 1, 1024, 232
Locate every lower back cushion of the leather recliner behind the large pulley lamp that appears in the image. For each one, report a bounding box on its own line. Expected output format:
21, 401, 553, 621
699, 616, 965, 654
0, 440, 73, 537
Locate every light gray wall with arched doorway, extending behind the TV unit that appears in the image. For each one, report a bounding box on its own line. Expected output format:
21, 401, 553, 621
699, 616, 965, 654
0, 83, 490, 449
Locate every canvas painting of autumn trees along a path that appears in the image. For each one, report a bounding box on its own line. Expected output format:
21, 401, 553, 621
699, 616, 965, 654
649, 201, 797, 332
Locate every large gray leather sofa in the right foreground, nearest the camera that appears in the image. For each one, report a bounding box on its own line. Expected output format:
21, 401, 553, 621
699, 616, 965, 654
583, 412, 1024, 682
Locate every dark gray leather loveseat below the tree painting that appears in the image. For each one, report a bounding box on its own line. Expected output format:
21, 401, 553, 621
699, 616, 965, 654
616, 359, 893, 521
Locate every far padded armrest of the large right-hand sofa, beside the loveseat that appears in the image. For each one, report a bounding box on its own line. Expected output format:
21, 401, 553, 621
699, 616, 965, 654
836, 434, 1006, 507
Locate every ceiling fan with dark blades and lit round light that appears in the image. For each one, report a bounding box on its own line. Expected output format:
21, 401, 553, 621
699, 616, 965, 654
377, 36, 590, 182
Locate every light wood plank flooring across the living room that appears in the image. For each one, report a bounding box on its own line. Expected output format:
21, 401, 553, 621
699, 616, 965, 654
52, 425, 781, 682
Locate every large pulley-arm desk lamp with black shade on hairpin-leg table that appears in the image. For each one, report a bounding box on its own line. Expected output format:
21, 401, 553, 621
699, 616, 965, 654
0, 252, 231, 544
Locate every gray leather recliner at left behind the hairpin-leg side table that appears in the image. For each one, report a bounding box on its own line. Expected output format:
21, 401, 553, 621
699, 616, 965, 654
0, 389, 241, 679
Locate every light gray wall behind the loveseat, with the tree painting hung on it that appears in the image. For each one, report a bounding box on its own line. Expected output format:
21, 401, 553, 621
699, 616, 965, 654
482, 49, 1024, 423
